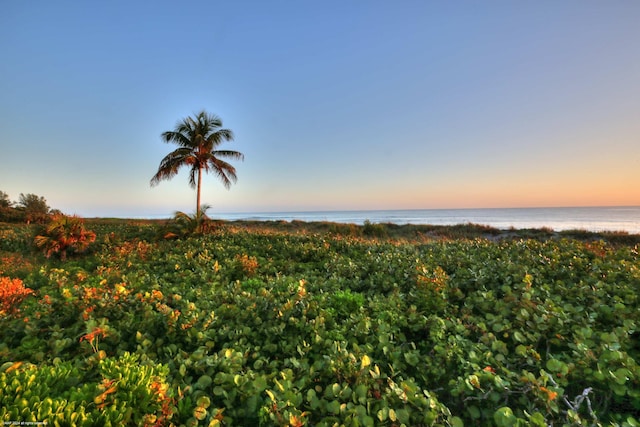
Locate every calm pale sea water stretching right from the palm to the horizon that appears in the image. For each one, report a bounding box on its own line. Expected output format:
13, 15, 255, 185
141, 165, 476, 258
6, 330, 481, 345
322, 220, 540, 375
210, 206, 640, 234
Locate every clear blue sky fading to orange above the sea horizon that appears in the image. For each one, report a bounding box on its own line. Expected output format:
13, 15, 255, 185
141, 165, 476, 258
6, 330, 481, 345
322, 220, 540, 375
0, 0, 640, 217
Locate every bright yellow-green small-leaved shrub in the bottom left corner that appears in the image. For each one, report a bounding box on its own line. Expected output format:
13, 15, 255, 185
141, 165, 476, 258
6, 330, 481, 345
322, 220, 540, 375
0, 352, 175, 427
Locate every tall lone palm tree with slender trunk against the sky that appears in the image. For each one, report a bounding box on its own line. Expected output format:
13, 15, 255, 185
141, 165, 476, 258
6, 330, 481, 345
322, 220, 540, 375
151, 111, 244, 216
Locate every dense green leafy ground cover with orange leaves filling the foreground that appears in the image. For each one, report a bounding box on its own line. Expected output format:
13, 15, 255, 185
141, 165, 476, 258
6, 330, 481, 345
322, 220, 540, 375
0, 222, 640, 427
